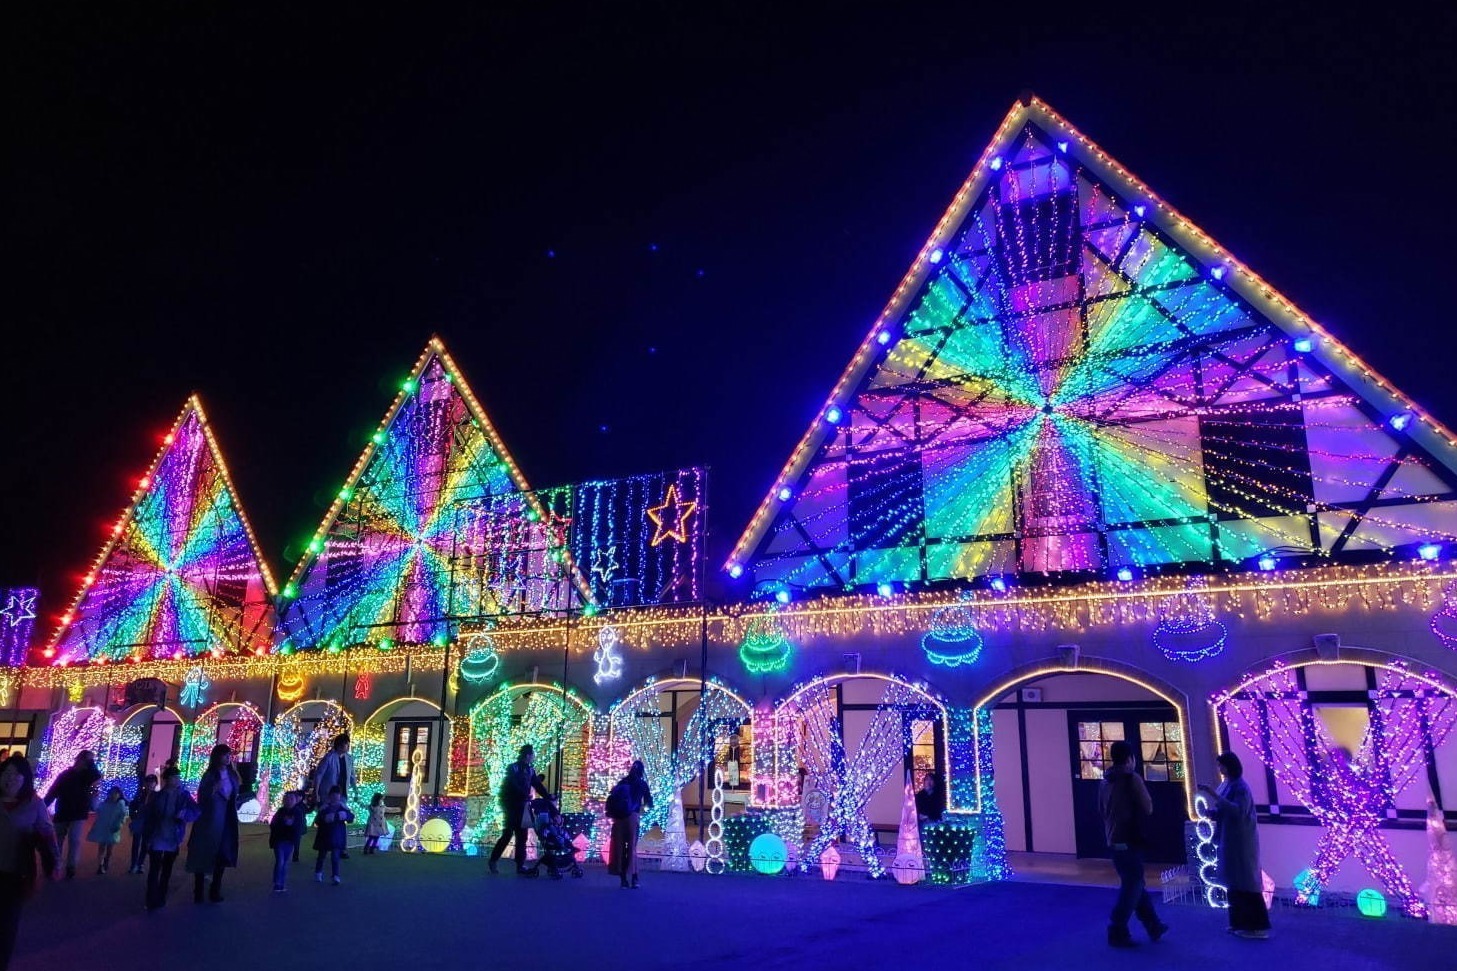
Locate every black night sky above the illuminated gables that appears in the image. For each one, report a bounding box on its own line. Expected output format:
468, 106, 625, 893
0, 3, 1457, 612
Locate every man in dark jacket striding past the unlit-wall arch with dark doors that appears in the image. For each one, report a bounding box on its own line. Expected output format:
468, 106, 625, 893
1097, 741, 1169, 948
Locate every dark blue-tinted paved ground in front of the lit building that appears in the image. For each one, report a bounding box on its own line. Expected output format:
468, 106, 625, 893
12, 835, 1457, 971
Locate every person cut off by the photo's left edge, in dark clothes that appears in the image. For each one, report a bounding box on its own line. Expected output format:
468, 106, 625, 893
0, 754, 61, 971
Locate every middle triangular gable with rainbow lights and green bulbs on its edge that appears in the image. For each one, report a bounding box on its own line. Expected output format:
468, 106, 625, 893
281, 338, 590, 650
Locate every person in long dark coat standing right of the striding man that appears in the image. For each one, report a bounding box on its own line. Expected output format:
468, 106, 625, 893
1199, 752, 1271, 940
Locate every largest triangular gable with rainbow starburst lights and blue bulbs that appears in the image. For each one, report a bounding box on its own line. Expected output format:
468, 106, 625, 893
727, 99, 1457, 590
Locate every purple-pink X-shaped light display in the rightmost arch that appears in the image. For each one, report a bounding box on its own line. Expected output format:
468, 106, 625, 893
1215, 665, 1457, 917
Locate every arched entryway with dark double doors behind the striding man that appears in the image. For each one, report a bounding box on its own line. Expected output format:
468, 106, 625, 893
976, 660, 1193, 863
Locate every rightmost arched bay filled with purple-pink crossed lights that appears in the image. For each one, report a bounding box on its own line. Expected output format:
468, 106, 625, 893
1212, 647, 1457, 916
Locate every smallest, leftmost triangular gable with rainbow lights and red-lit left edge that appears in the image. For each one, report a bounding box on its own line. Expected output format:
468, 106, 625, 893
45, 395, 277, 665
